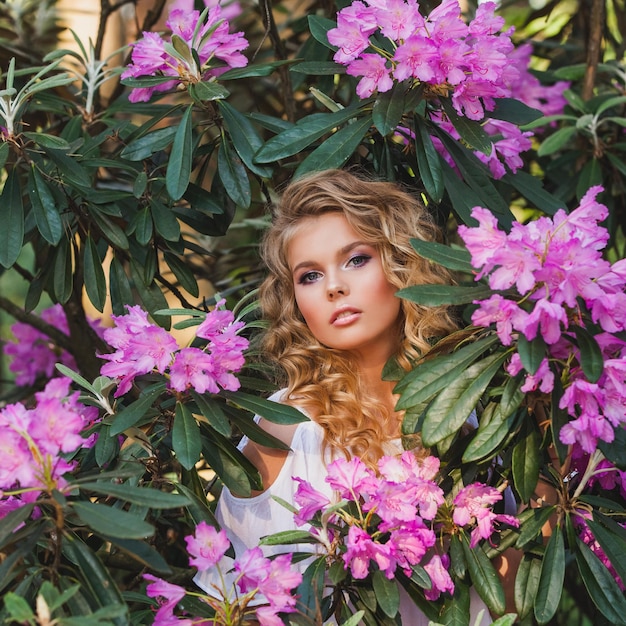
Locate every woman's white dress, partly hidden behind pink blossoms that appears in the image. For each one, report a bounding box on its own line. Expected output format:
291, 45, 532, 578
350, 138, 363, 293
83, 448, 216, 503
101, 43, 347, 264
194, 391, 491, 626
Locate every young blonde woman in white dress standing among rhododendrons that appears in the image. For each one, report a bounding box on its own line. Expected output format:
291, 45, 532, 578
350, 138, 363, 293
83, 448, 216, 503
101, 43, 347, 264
196, 171, 491, 626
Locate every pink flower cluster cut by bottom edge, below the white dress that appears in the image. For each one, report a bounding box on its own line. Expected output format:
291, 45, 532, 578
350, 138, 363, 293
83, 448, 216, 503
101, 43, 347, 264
144, 522, 302, 626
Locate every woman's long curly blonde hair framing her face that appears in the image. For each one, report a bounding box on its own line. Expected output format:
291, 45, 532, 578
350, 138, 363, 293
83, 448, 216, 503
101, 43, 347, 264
260, 170, 456, 466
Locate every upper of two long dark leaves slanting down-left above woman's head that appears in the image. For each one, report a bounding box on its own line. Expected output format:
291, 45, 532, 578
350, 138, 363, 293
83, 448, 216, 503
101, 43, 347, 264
254, 107, 357, 163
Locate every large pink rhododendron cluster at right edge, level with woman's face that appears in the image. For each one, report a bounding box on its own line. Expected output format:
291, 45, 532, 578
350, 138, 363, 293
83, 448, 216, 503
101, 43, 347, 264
459, 187, 626, 453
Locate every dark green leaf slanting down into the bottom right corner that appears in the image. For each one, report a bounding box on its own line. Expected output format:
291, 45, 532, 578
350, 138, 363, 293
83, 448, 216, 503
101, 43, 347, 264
576, 538, 626, 624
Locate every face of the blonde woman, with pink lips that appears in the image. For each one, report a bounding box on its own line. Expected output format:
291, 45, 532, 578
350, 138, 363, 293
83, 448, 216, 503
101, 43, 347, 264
287, 213, 401, 361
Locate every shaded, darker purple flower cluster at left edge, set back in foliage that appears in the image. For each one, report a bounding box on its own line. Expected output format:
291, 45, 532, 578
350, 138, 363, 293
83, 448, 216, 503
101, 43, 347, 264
4, 304, 102, 385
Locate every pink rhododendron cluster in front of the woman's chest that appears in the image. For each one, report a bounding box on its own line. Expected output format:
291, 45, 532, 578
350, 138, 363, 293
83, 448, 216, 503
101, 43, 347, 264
294, 451, 518, 600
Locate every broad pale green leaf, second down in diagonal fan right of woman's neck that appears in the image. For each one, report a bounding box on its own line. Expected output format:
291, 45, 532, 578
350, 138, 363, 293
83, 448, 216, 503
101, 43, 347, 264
422, 353, 507, 446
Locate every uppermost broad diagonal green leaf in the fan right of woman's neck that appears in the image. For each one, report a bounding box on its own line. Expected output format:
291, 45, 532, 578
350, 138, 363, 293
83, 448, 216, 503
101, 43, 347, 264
394, 335, 498, 411
